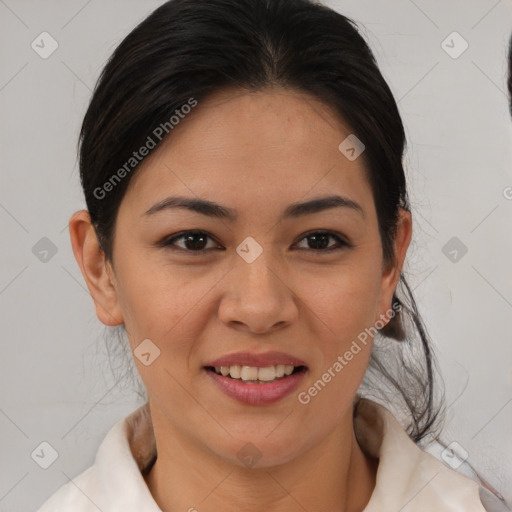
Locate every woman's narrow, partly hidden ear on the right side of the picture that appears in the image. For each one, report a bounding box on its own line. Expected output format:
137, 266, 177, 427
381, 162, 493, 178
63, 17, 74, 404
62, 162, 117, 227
379, 208, 412, 316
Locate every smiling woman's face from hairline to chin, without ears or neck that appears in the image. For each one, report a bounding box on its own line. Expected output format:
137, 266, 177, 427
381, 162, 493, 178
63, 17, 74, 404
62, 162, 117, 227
96, 89, 409, 466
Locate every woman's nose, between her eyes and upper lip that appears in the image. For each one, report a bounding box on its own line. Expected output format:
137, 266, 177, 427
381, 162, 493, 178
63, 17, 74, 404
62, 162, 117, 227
218, 250, 298, 334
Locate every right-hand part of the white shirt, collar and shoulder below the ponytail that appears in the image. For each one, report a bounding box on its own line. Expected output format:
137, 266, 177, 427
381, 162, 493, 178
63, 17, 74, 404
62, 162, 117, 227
354, 399, 509, 512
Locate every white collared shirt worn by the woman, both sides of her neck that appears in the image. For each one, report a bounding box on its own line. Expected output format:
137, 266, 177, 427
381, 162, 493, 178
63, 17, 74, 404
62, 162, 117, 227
37, 399, 509, 512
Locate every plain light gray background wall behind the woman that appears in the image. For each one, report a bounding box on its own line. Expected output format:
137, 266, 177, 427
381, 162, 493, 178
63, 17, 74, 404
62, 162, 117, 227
0, 0, 512, 512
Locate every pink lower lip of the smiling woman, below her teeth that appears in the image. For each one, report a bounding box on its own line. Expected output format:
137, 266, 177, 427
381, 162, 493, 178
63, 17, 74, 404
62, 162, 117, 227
205, 369, 306, 405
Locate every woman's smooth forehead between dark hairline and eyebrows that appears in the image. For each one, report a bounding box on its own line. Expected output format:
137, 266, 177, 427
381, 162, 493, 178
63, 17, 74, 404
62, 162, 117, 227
122, 89, 371, 222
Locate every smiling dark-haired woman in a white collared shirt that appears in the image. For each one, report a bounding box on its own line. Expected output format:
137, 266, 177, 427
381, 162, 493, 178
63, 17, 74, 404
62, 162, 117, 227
36, 0, 508, 512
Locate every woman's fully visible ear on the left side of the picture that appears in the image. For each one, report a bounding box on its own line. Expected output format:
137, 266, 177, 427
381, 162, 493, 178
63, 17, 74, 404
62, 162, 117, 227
69, 210, 123, 326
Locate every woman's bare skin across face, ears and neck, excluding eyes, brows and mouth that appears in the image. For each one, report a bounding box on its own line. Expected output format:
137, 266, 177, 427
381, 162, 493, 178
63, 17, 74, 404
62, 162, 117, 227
69, 89, 411, 512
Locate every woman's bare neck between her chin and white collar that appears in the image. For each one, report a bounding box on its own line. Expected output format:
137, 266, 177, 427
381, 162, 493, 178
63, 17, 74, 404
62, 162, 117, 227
145, 408, 378, 512
